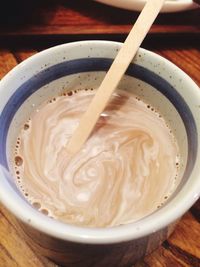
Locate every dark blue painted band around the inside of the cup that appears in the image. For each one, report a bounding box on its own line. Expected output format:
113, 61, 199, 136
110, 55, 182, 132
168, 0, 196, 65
0, 58, 197, 180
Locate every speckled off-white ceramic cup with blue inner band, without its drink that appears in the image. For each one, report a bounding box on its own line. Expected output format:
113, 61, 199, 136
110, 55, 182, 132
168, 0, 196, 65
0, 41, 200, 267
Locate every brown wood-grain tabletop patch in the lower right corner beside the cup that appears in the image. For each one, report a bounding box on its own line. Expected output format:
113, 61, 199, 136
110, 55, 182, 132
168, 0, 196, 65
144, 212, 200, 267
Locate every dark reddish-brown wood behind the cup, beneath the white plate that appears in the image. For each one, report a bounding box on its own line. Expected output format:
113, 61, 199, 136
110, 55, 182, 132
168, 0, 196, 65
0, 0, 200, 38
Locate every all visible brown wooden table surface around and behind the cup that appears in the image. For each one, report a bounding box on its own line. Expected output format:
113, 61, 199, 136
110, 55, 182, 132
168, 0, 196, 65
0, 0, 200, 267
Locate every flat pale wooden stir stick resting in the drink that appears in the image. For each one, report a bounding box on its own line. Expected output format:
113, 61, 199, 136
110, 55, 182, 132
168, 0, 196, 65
67, 0, 165, 155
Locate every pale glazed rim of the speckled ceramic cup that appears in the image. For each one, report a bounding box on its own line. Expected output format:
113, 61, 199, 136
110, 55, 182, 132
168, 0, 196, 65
0, 40, 200, 244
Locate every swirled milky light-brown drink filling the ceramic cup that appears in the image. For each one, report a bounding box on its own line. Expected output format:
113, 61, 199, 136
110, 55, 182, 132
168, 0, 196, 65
14, 90, 179, 227
